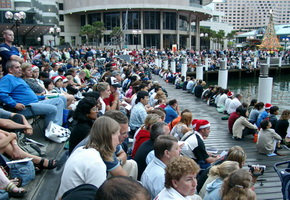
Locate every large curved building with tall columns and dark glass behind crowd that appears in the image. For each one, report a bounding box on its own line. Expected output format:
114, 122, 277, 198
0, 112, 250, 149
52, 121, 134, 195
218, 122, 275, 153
59, 0, 212, 49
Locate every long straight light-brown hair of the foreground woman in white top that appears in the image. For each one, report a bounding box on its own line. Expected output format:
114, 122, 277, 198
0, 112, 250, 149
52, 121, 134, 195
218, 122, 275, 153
86, 116, 120, 161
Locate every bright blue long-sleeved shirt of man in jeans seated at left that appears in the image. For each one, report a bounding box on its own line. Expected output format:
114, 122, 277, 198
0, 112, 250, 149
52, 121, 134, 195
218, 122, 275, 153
0, 74, 44, 108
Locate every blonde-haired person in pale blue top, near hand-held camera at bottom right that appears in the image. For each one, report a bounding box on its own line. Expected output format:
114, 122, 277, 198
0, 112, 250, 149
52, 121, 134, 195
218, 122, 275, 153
199, 161, 240, 200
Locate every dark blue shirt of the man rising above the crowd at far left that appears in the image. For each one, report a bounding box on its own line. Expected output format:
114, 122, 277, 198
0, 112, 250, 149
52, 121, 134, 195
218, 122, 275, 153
0, 43, 20, 74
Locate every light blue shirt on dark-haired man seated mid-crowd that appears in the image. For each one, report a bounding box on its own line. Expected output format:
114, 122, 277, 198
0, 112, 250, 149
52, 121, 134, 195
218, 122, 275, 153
129, 102, 147, 130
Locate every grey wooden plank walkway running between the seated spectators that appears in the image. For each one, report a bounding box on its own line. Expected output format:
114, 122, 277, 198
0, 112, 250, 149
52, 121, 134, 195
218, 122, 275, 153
153, 75, 290, 200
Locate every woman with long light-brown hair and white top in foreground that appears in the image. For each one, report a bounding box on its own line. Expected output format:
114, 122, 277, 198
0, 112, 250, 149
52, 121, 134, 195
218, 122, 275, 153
56, 116, 120, 199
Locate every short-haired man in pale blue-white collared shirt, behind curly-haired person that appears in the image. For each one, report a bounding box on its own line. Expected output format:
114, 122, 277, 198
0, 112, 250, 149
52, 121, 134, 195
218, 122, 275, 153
141, 135, 180, 198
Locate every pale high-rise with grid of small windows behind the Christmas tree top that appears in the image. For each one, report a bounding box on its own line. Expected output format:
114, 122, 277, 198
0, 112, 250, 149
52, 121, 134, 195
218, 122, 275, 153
214, 0, 290, 31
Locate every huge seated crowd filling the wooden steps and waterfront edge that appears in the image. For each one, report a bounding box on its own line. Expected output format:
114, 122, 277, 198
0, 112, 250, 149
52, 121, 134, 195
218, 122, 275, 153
0, 30, 290, 200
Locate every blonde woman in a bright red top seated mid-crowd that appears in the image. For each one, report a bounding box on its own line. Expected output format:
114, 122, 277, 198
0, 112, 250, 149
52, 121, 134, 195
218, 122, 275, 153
132, 114, 162, 158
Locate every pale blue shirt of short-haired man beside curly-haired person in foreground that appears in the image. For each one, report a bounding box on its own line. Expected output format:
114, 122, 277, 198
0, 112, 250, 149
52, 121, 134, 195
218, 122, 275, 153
141, 157, 166, 198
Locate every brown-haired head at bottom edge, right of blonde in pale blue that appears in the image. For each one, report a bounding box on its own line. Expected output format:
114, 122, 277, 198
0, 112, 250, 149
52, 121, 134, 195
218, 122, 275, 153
221, 169, 256, 200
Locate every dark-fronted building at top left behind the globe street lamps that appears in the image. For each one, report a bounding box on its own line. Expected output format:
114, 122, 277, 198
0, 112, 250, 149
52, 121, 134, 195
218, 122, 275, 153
0, 0, 59, 45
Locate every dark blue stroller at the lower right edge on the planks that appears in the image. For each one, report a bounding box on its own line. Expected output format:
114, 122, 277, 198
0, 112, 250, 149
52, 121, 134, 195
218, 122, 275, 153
274, 160, 290, 200
